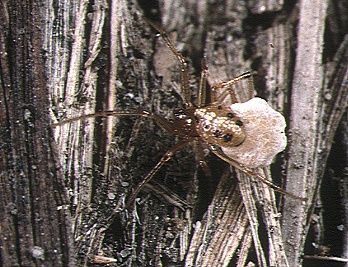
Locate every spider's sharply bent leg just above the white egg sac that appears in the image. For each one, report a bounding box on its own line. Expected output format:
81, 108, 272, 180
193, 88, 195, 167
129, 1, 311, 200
212, 71, 254, 103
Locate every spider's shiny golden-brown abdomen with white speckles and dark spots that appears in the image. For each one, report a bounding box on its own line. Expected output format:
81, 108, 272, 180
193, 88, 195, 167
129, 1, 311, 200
194, 105, 245, 147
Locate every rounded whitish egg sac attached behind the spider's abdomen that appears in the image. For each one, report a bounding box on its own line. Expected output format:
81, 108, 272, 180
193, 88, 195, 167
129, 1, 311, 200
221, 97, 287, 168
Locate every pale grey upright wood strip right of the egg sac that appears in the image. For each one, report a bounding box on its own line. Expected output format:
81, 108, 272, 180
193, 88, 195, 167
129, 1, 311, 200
283, 0, 327, 266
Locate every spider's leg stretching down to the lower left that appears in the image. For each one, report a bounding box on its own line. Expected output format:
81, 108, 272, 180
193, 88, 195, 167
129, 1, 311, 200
127, 140, 191, 207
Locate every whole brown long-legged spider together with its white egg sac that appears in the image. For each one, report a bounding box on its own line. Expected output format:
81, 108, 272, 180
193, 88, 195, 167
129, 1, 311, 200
54, 22, 305, 206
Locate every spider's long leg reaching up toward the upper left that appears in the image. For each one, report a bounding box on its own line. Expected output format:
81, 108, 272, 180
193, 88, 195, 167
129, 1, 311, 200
147, 20, 193, 108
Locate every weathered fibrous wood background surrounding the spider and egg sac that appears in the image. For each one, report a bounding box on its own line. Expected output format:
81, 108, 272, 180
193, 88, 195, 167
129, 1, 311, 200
0, 0, 348, 266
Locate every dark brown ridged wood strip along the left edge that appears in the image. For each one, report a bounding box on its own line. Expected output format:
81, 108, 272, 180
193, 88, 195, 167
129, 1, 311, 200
0, 1, 75, 266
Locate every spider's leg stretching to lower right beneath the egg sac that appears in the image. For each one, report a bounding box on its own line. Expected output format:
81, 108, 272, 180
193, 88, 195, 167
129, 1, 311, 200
210, 146, 307, 201
